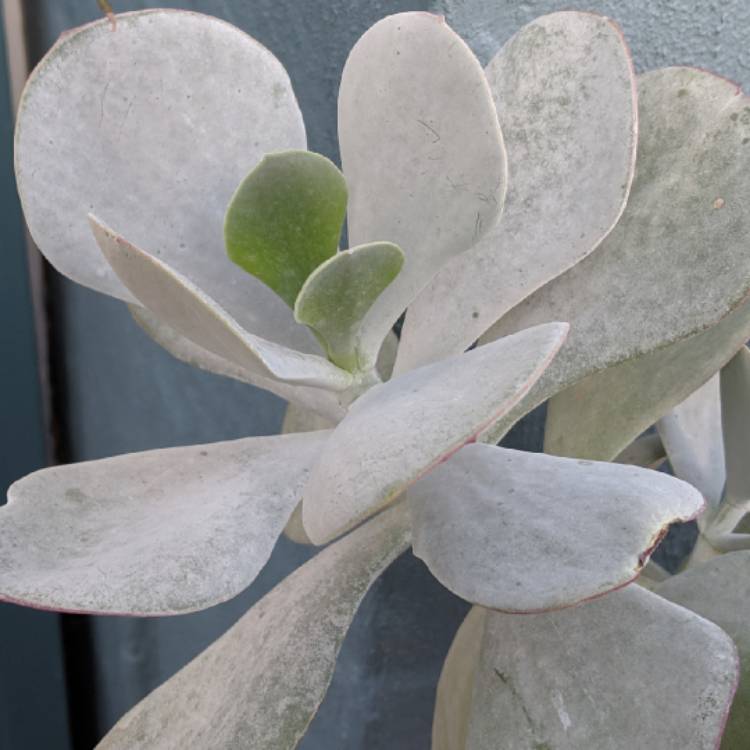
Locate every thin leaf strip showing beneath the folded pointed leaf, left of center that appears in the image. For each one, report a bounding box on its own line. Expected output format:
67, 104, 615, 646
128, 305, 346, 422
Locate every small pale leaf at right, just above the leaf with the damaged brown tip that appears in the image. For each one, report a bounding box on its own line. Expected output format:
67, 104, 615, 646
656, 374, 726, 506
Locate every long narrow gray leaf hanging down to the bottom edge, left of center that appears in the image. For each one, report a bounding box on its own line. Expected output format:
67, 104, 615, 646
98, 507, 409, 750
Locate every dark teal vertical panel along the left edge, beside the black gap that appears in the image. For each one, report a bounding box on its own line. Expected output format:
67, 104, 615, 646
0, 5, 69, 750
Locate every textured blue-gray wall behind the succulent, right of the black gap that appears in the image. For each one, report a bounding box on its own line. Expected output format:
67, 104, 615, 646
16, 0, 750, 750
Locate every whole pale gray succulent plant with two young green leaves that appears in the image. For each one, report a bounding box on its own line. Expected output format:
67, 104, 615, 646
0, 10, 750, 750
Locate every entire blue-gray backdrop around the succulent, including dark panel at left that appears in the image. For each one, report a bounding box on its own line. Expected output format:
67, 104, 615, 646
0, 0, 750, 750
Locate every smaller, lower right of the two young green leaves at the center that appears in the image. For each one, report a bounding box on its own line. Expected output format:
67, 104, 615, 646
294, 242, 404, 371
